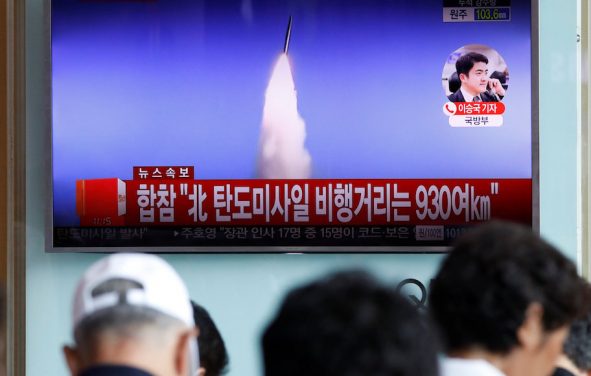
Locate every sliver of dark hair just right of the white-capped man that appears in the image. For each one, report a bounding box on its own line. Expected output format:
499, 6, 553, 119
191, 301, 229, 376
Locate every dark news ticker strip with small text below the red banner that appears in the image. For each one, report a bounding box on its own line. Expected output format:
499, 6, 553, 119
53, 225, 490, 251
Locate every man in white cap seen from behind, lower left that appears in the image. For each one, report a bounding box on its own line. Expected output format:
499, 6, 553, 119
64, 254, 198, 376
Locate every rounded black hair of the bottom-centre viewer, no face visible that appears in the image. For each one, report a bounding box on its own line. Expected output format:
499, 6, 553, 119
262, 271, 437, 376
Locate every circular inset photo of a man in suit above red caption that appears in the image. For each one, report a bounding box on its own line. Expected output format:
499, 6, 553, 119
441, 44, 509, 103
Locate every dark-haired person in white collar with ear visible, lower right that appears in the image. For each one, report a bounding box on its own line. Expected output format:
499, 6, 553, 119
429, 222, 589, 376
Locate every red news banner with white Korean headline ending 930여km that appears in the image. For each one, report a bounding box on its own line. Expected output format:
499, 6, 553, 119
76, 166, 532, 227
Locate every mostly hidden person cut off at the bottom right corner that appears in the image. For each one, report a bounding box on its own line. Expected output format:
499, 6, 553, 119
553, 313, 591, 376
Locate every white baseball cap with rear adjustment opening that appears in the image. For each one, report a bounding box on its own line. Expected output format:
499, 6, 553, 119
73, 253, 195, 328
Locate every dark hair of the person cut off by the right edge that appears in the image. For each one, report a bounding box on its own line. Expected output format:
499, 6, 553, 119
564, 312, 591, 372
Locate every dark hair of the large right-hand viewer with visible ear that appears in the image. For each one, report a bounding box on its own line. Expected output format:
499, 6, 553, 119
429, 222, 589, 354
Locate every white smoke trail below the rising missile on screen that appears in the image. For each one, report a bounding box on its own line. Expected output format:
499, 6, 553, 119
257, 53, 312, 179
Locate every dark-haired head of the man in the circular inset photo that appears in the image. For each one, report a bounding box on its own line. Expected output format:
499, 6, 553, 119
456, 52, 488, 95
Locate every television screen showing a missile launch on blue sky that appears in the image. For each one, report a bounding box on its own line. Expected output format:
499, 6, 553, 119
48, 0, 537, 252
